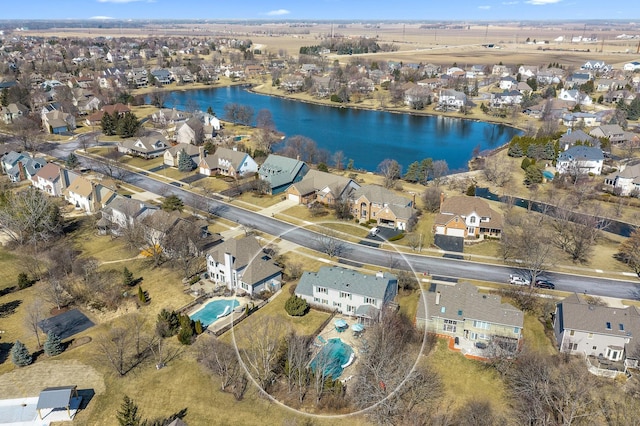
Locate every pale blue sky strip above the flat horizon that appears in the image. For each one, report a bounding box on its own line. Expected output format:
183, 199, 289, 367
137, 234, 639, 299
0, 0, 640, 22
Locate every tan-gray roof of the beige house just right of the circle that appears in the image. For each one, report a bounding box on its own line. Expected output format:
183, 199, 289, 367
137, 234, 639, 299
416, 282, 524, 327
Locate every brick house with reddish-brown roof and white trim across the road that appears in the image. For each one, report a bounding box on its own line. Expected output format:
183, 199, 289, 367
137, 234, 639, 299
433, 194, 502, 238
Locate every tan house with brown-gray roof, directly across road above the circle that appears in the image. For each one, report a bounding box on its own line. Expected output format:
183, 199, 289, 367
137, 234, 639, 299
349, 185, 415, 230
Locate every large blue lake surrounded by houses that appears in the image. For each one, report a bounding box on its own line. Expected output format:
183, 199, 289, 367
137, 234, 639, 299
160, 86, 521, 171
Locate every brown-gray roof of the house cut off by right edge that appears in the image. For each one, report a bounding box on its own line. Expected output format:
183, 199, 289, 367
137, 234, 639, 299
558, 294, 640, 336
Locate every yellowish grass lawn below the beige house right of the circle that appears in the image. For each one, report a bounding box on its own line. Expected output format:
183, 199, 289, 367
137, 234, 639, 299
426, 339, 508, 414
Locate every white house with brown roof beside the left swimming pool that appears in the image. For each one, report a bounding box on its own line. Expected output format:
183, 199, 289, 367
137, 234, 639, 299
206, 237, 282, 296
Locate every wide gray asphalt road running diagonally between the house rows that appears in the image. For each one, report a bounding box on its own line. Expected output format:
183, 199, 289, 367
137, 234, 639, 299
42, 139, 640, 299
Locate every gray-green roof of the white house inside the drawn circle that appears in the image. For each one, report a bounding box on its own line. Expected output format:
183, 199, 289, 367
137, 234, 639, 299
296, 266, 398, 300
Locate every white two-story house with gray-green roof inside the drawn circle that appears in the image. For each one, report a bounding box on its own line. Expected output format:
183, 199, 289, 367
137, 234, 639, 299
295, 266, 398, 320
